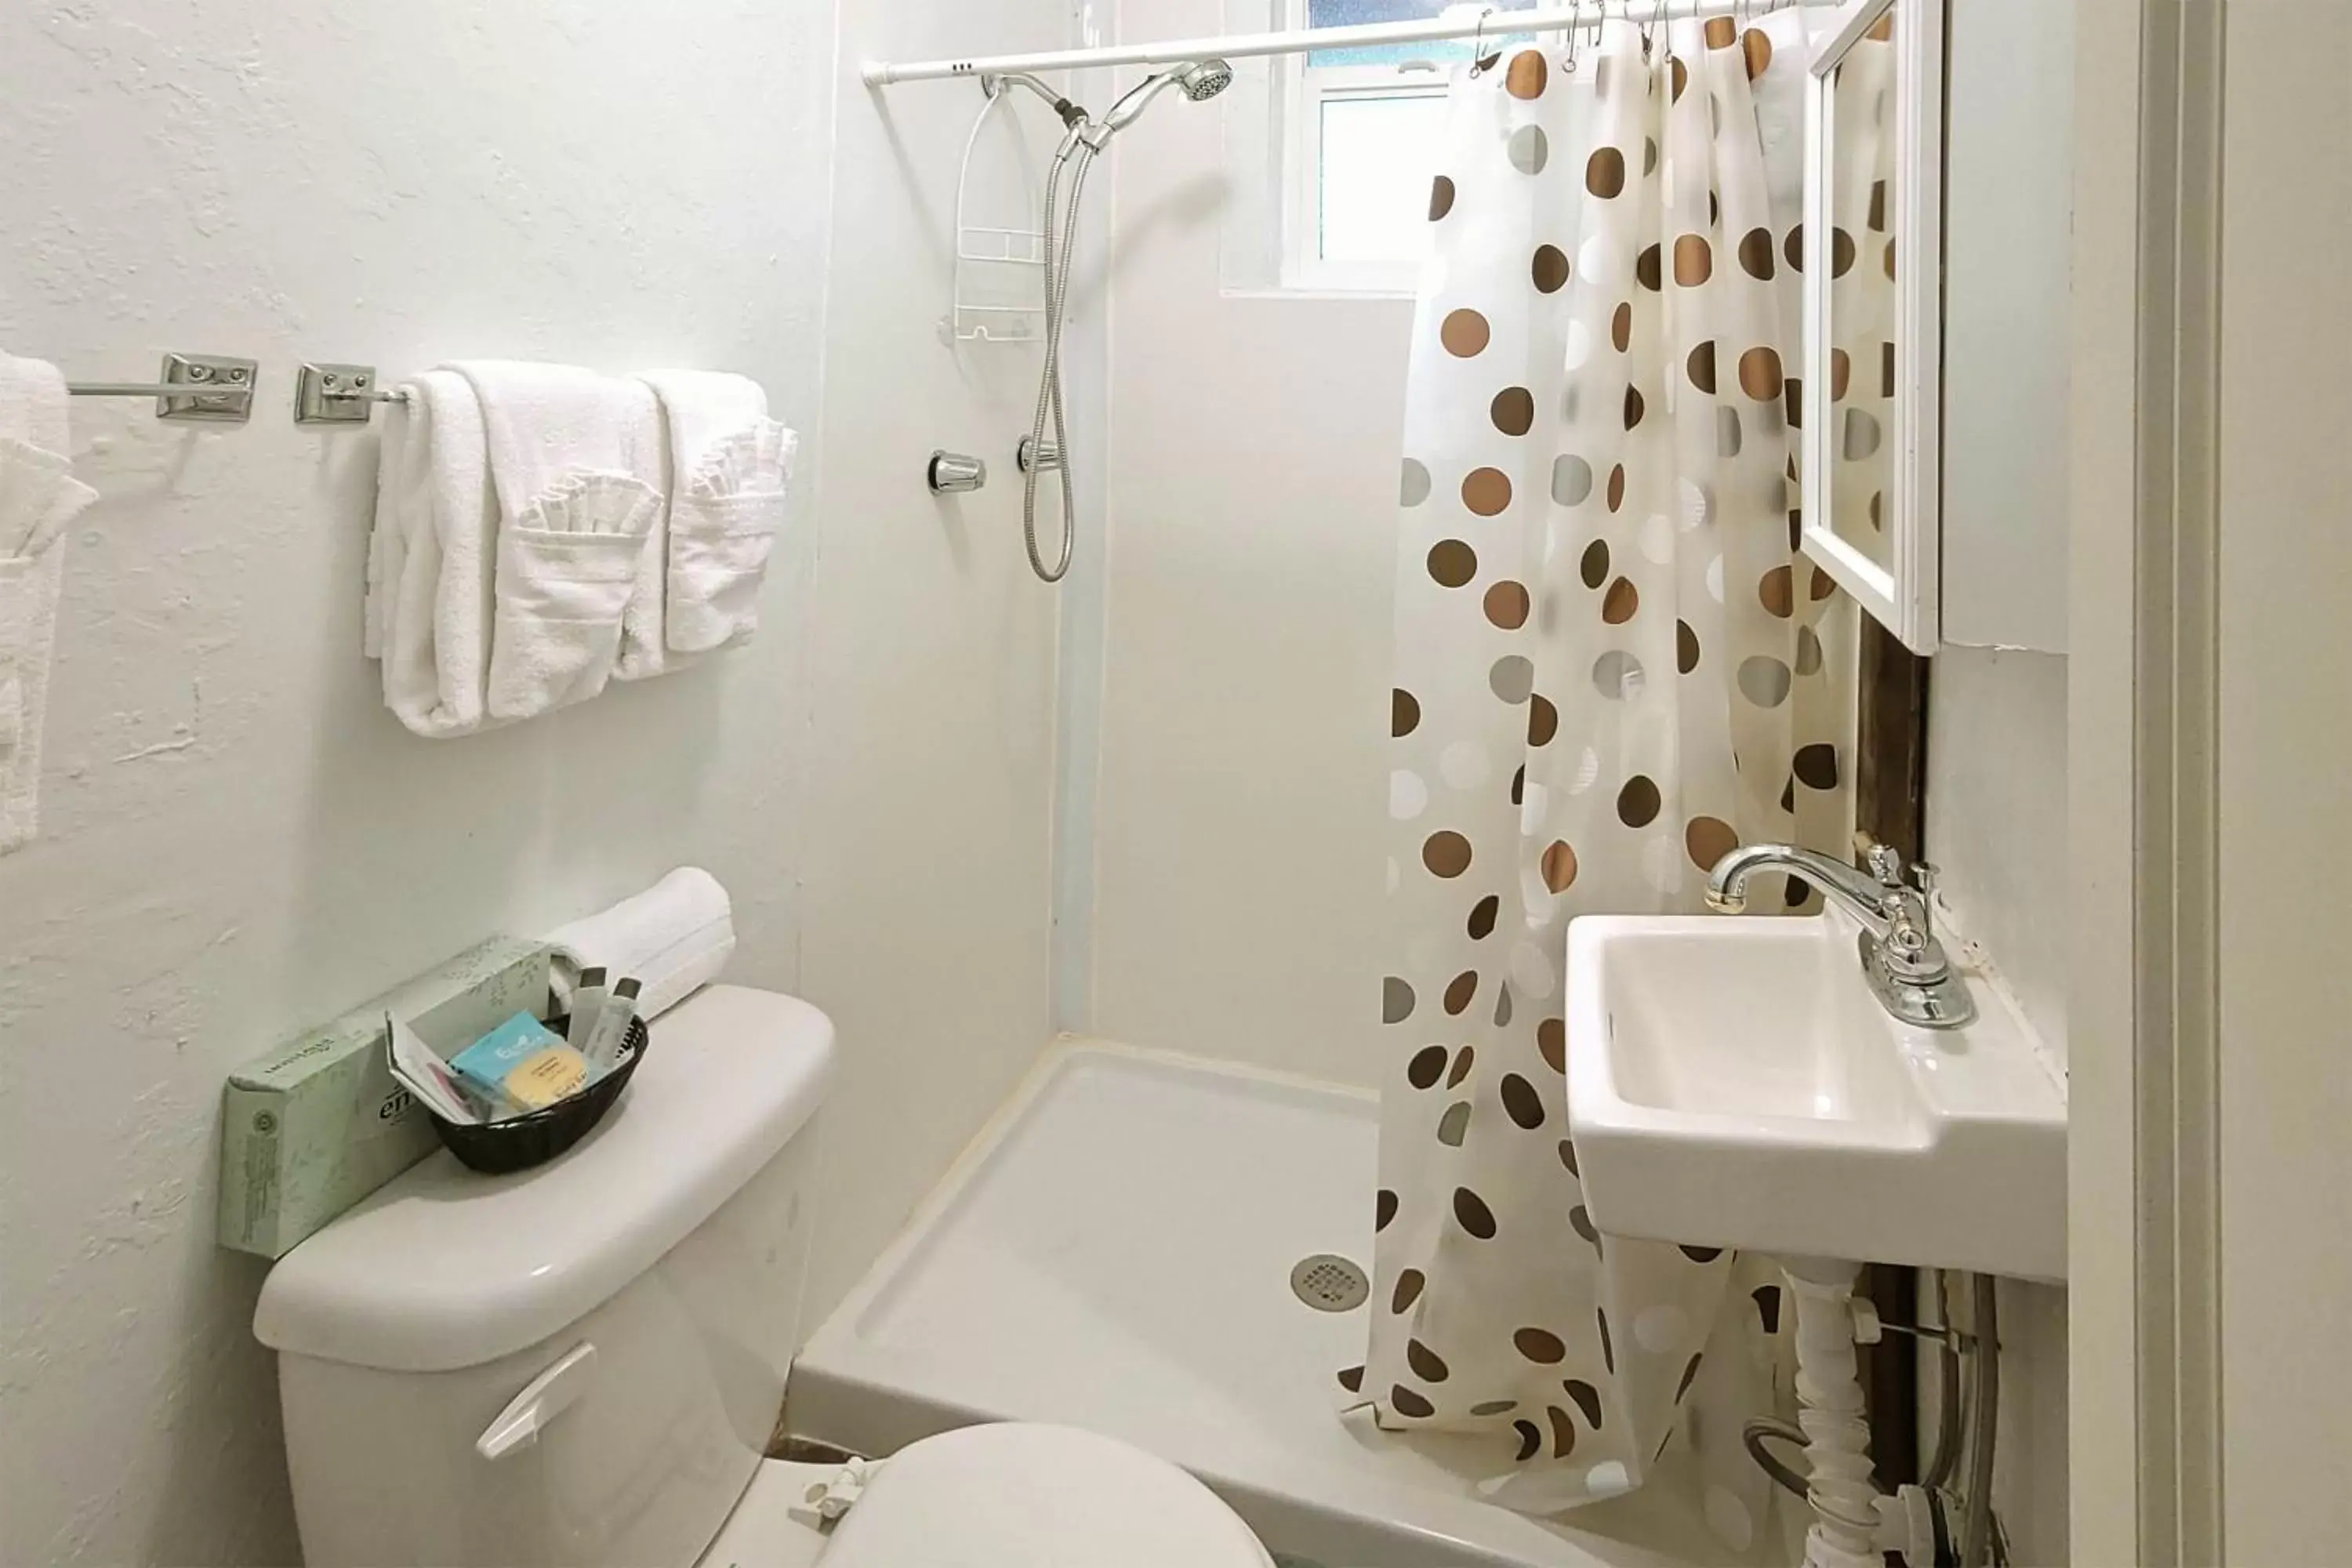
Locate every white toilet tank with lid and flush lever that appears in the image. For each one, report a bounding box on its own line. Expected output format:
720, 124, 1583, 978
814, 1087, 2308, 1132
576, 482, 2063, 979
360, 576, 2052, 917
254, 985, 833, 1568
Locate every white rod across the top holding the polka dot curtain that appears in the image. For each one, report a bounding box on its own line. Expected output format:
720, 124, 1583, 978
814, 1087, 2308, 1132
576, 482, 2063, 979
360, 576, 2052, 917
863, 0, 1797, 87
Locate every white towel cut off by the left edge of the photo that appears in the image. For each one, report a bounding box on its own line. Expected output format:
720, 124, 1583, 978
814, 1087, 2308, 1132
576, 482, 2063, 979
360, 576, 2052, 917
0, 353, 96, 855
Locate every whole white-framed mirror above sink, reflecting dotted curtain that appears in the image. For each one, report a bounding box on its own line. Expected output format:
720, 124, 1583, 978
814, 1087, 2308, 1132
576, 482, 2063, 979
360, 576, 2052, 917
1802, 0, 1943, 654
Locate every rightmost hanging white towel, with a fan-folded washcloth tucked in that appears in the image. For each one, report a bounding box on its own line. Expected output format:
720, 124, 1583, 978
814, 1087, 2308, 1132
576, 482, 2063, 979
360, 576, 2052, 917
642, 369, 800, 656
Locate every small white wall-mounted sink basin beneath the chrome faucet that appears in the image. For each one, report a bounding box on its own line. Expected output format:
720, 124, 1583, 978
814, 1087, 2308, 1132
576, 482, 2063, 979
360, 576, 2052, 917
1569, 909, 2065, 1279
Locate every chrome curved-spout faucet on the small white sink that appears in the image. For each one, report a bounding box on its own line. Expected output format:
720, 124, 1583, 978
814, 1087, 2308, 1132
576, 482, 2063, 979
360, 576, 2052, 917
1708, 844, 1976, 1029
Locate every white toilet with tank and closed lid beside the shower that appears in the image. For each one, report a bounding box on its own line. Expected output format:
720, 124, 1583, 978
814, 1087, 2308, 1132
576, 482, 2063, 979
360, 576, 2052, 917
254, 985, 1272, 1568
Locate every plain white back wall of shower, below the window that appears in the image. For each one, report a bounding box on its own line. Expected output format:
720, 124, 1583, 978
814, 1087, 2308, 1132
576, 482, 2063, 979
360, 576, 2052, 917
1073, 0, 1414, 1083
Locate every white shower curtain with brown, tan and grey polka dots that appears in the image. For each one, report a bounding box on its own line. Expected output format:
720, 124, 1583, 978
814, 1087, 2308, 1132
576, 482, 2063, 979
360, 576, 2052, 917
1341, 12, 1853, 1549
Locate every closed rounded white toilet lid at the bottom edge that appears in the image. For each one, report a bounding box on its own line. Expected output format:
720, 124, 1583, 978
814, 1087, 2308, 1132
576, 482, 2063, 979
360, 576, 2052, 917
818, 1422, 1272, 1568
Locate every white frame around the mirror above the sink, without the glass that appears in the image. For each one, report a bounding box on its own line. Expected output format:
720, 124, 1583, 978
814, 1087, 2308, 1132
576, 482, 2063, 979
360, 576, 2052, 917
1799, 0, 1943, 654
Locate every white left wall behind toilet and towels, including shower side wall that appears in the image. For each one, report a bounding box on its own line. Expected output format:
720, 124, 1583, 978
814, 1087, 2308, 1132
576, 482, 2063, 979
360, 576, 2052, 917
0, 0, 1065, 1563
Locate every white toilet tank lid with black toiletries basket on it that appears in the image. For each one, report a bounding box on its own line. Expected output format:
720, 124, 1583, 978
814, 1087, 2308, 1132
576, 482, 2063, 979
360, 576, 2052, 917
254, 985, 833, 1373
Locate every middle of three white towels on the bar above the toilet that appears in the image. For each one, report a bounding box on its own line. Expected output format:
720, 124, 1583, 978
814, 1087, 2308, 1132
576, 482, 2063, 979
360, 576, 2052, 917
449, 360, 663, 720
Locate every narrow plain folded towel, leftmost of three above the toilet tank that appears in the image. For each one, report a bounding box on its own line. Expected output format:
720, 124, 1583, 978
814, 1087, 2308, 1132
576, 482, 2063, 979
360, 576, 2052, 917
367, 372, 494, 739
